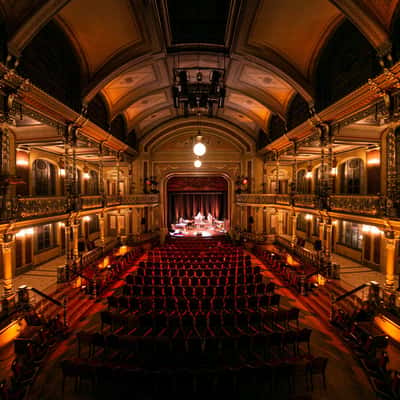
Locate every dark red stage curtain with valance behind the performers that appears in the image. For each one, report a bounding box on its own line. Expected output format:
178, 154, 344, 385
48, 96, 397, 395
168, 177, 227, 225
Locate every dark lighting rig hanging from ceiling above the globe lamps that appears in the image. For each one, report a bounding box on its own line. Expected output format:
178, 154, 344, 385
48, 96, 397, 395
172, 67, 225, 117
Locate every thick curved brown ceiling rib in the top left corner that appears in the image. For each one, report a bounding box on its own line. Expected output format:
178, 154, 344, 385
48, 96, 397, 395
8, 0, 70, 58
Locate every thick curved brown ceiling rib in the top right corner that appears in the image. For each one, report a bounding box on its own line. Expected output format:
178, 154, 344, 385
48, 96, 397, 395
330, 0, 392, 56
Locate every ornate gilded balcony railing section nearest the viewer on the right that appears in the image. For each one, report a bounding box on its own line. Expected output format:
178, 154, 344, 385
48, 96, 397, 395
329, 194, 384, 215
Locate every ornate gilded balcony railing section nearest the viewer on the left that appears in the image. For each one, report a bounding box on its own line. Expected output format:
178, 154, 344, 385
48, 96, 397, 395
17, 196, 67, 218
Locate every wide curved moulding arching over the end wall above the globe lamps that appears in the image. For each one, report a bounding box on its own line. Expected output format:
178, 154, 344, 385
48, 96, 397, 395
140, 118, 255, 152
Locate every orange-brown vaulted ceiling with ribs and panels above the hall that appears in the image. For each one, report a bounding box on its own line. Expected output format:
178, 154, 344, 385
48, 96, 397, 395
0, 0, 398, 150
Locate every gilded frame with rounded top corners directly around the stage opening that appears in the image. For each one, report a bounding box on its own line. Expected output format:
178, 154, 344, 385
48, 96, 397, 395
160, 170, 235, 229
